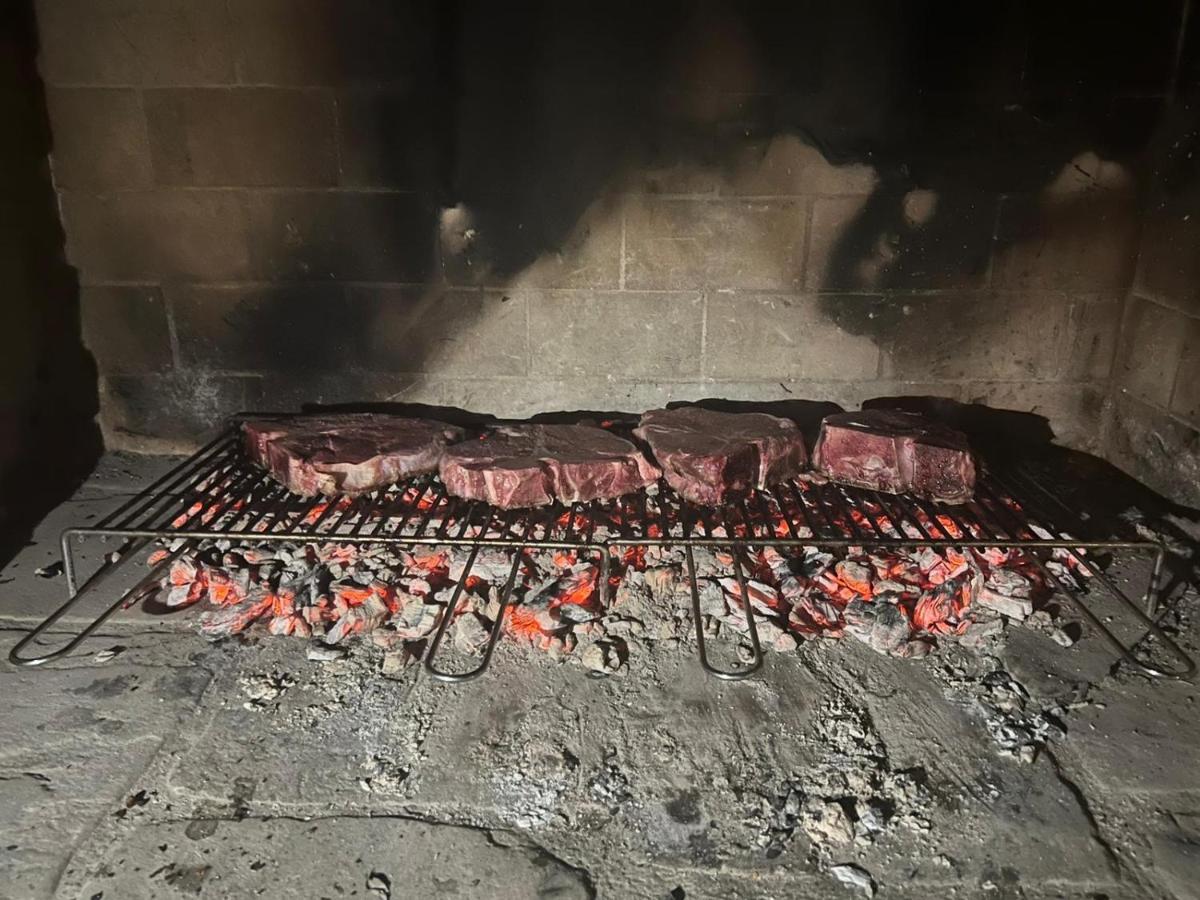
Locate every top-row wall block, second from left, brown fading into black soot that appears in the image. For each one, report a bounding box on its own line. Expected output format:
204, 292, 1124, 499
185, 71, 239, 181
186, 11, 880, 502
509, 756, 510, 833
228, 0, 434, 85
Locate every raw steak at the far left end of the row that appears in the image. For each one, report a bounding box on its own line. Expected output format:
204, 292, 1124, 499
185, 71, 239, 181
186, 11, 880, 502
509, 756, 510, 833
241, 413, 463, 497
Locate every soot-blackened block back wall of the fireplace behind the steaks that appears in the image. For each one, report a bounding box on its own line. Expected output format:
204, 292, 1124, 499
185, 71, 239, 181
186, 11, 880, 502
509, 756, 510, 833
38, 0, 1184, 494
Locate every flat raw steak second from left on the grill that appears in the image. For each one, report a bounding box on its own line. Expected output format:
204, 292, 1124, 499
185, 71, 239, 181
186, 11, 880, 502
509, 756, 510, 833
439, 425, 659, 509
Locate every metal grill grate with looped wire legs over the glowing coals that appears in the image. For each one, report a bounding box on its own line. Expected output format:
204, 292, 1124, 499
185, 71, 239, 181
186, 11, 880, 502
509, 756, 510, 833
8, 424, 1195, 683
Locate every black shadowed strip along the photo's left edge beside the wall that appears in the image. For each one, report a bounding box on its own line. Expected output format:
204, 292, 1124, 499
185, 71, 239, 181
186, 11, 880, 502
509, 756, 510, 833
0, 0, 101, 565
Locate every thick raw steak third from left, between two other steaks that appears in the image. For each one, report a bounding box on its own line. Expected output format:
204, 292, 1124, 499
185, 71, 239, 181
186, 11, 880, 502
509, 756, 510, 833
634, 407, 808, 505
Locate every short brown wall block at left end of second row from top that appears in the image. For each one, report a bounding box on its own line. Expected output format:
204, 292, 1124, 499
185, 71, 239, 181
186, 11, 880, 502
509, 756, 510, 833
46, 88, 154, 190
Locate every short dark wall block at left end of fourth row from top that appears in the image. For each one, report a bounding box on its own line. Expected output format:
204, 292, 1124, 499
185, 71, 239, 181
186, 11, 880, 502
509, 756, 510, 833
79, 287, 172, 374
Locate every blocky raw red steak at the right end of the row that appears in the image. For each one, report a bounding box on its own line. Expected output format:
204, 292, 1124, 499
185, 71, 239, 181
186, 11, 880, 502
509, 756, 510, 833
812, 409, 976, 503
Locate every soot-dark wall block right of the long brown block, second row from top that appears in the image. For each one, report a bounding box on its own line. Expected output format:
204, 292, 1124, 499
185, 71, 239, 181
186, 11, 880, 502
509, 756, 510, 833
337, 88, 442, 191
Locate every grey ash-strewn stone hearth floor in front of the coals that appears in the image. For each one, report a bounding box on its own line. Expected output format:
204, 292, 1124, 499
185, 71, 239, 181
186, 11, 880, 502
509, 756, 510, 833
0, 457, 1200, 899
